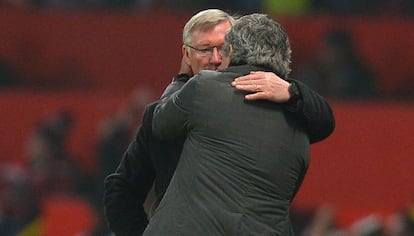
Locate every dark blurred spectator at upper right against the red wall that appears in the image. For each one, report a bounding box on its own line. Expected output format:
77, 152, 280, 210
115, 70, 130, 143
293, 30, 378, 99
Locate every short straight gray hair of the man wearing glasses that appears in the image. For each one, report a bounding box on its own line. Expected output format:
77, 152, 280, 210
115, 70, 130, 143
183, 9, 234, 45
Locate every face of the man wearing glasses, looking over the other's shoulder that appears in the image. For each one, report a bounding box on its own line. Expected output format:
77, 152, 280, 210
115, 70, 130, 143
183, 21, 231, 74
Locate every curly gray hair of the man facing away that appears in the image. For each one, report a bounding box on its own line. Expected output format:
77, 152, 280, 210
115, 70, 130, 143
223, 13, 292, 79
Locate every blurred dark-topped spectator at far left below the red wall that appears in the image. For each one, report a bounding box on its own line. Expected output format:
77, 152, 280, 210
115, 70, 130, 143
27, 110, 91, 199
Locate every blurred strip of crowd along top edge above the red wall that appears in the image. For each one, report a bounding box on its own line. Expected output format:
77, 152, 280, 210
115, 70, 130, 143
0, 0, 414, 17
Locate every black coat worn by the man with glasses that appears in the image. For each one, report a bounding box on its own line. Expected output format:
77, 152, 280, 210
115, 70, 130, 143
104, 66, 335, 236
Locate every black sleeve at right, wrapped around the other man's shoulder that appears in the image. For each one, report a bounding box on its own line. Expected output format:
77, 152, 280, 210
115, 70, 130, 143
288, 80, 335, 143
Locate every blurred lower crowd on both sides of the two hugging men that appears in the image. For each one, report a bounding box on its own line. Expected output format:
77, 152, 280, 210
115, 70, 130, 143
0, 107, 414, 236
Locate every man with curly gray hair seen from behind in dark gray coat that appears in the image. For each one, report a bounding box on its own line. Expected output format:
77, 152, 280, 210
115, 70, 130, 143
144, 14, 322, 236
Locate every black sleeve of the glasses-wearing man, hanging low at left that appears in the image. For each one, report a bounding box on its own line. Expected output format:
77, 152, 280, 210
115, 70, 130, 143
104, 106, 155, 236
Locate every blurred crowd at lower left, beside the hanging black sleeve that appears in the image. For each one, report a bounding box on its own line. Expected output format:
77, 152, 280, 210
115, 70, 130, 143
0, 90, 152, 236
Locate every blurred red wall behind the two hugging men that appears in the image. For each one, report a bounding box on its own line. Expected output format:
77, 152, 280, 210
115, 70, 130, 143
0, 9, 414, 234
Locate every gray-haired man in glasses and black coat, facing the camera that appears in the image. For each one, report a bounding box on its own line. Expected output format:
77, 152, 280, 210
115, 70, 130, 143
104, 9, 335, 235
